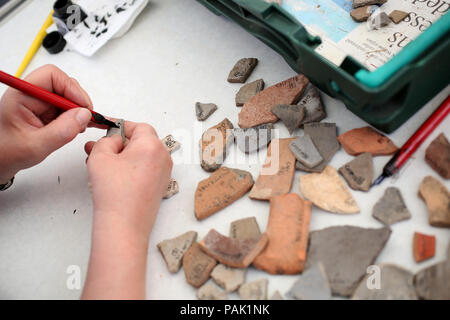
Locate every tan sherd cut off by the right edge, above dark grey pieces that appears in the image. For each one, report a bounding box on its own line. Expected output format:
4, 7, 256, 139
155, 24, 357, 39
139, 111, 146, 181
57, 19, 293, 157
419, 176, 450, 228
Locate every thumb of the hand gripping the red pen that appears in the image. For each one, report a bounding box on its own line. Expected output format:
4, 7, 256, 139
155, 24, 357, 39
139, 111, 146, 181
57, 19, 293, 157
38, 108, 92, 154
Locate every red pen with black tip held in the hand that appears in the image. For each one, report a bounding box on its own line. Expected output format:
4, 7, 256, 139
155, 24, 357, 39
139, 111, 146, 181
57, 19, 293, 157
0, 70, 118, 128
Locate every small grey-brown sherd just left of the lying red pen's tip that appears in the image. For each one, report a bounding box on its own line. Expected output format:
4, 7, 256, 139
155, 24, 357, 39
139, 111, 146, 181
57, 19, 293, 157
339, 152, 373, 191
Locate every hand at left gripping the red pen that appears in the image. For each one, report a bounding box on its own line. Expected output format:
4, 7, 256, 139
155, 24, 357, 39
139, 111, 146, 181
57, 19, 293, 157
0, 65, 92, 184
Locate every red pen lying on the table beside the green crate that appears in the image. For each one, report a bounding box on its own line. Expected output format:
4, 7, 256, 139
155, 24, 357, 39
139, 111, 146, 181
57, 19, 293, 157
372, 96, 450, 186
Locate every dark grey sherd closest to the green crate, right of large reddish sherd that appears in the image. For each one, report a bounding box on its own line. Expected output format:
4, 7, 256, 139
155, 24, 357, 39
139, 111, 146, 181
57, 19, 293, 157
297, 83, 327, 126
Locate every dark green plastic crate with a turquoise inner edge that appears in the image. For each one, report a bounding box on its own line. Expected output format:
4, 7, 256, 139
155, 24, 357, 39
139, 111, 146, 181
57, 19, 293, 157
197, 0, 450, 133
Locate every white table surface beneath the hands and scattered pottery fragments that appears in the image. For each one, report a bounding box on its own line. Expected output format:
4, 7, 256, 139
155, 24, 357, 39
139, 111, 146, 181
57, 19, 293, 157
0, 0, 450, 299
